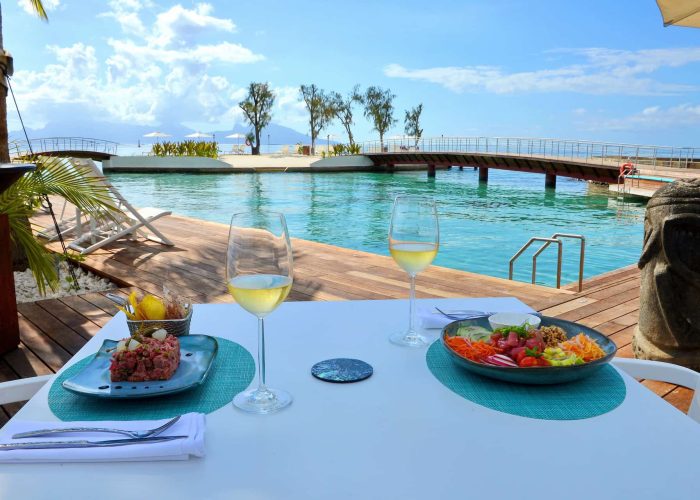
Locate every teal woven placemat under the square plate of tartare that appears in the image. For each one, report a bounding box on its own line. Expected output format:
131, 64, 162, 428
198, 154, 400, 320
49, 337, 255, 420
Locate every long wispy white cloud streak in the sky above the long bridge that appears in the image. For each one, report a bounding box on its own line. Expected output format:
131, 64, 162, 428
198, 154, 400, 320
384, 47, 700, 95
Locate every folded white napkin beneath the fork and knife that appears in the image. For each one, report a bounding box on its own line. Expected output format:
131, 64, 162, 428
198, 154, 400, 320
0, 413, 206, 463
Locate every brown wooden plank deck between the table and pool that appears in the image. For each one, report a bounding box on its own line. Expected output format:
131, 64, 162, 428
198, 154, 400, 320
0, 216, 692, 425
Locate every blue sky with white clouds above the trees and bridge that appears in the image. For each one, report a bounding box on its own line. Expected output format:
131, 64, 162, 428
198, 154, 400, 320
2, 0, 700, 146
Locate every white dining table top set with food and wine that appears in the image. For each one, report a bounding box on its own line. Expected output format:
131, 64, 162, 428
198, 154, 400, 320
0, 298, 700, 500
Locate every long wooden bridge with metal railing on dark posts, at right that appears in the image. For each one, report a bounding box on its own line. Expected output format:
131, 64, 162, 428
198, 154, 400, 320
361, 137, 700, 187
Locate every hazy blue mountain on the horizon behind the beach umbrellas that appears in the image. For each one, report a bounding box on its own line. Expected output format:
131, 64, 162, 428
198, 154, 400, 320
10, 117, 311, 146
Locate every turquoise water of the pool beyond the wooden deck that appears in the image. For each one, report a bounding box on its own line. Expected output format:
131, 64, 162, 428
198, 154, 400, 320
109, 168, 645, 284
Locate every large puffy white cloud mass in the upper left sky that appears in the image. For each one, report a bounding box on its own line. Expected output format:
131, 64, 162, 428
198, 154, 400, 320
11, 0, 264, 129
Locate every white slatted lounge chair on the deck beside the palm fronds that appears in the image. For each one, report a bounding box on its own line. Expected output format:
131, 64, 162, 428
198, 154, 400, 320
39, 158, 174, 254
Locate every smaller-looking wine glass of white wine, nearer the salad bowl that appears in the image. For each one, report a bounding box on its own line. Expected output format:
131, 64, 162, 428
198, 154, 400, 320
389, 196, 440, 347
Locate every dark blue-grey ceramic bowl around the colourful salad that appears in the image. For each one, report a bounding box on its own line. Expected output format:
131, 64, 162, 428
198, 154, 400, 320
440, 316, 617, 385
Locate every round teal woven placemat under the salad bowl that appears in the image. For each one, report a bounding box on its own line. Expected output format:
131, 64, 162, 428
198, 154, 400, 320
425, 341, 627, 420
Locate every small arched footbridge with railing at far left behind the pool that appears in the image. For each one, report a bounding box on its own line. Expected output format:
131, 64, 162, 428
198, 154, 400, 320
10, 137, 119, 161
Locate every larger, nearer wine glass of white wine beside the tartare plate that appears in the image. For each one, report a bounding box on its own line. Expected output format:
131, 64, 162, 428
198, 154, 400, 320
226, 213, 293, 413
